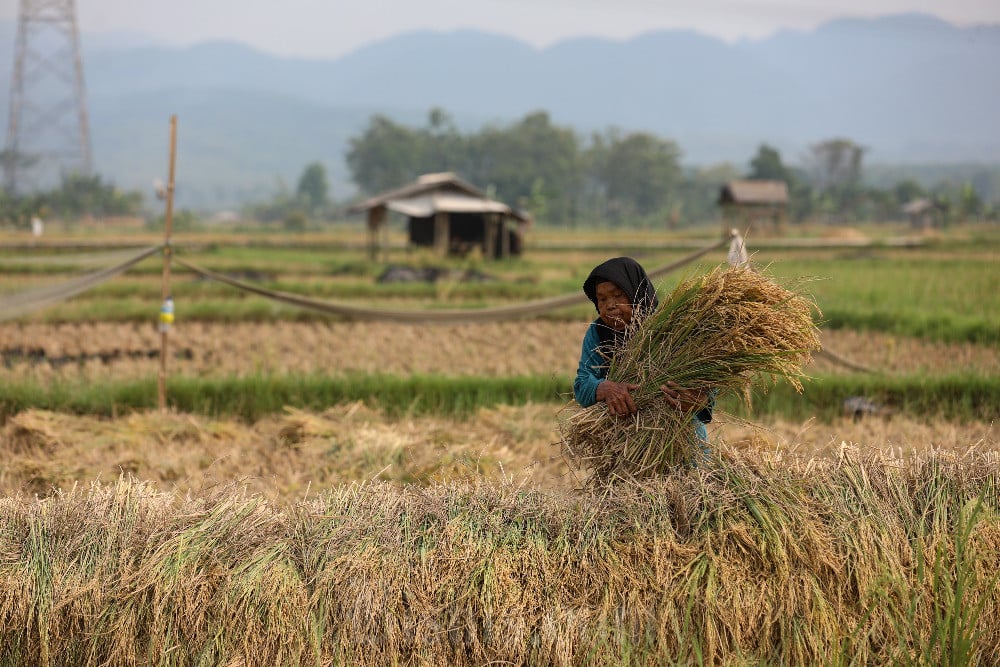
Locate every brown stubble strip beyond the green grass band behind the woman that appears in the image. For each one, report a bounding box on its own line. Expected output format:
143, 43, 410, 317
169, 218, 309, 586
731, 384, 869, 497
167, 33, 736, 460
0, 320, 1000, 379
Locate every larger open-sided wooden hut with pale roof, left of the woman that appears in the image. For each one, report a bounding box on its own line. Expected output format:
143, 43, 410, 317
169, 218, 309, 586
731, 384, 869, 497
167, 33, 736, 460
348, 172, 530, 258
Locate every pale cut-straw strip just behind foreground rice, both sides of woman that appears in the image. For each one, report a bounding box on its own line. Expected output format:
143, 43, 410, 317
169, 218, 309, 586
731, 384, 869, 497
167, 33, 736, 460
0, 403, 1000, 502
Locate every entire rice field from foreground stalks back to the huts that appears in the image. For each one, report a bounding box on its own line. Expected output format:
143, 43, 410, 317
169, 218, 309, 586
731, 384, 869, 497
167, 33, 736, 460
0, 225, 1000, 665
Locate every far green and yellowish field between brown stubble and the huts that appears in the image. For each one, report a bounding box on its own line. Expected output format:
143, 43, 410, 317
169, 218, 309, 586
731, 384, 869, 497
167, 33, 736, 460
0, 241, 1000, 345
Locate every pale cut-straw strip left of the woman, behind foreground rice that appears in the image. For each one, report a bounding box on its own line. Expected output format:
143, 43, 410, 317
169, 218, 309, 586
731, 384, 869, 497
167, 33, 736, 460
0, 403, 569, 501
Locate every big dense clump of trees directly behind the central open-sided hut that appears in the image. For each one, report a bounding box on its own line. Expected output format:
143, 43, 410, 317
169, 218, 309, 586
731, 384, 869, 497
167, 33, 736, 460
347, 108, 712, 224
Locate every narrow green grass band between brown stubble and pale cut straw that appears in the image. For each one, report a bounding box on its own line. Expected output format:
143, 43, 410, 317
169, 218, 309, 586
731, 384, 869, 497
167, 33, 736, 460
0, 373, 1000, 421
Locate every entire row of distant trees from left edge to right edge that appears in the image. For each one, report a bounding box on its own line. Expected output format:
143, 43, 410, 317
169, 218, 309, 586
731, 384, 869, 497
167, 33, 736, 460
0, 108, 1000, 231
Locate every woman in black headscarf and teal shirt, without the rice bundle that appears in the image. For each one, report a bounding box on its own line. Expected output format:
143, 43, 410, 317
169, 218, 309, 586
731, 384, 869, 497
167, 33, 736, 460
573, 257, 714, 442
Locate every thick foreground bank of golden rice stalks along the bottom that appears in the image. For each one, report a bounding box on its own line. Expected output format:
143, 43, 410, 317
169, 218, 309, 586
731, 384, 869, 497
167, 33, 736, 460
0, 449, 1000, 665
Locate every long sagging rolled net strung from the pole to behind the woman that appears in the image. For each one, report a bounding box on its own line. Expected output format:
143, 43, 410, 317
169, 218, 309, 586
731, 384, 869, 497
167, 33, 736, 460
173, 238, 730, 324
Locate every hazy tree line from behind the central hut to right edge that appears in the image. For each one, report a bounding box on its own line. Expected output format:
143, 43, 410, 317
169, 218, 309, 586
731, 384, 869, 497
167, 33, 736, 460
346, 109, 1000, 226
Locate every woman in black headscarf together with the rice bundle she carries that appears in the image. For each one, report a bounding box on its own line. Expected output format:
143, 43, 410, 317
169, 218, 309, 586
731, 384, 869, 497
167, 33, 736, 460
562, 258, 820, 485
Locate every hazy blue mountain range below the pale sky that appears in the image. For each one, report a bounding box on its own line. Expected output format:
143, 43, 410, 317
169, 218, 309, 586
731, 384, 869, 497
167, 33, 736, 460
0, 14, 1000, 207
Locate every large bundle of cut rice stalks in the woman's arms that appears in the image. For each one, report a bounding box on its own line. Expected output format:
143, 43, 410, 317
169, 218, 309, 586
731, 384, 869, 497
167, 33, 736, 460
562, 267, 820, 484
